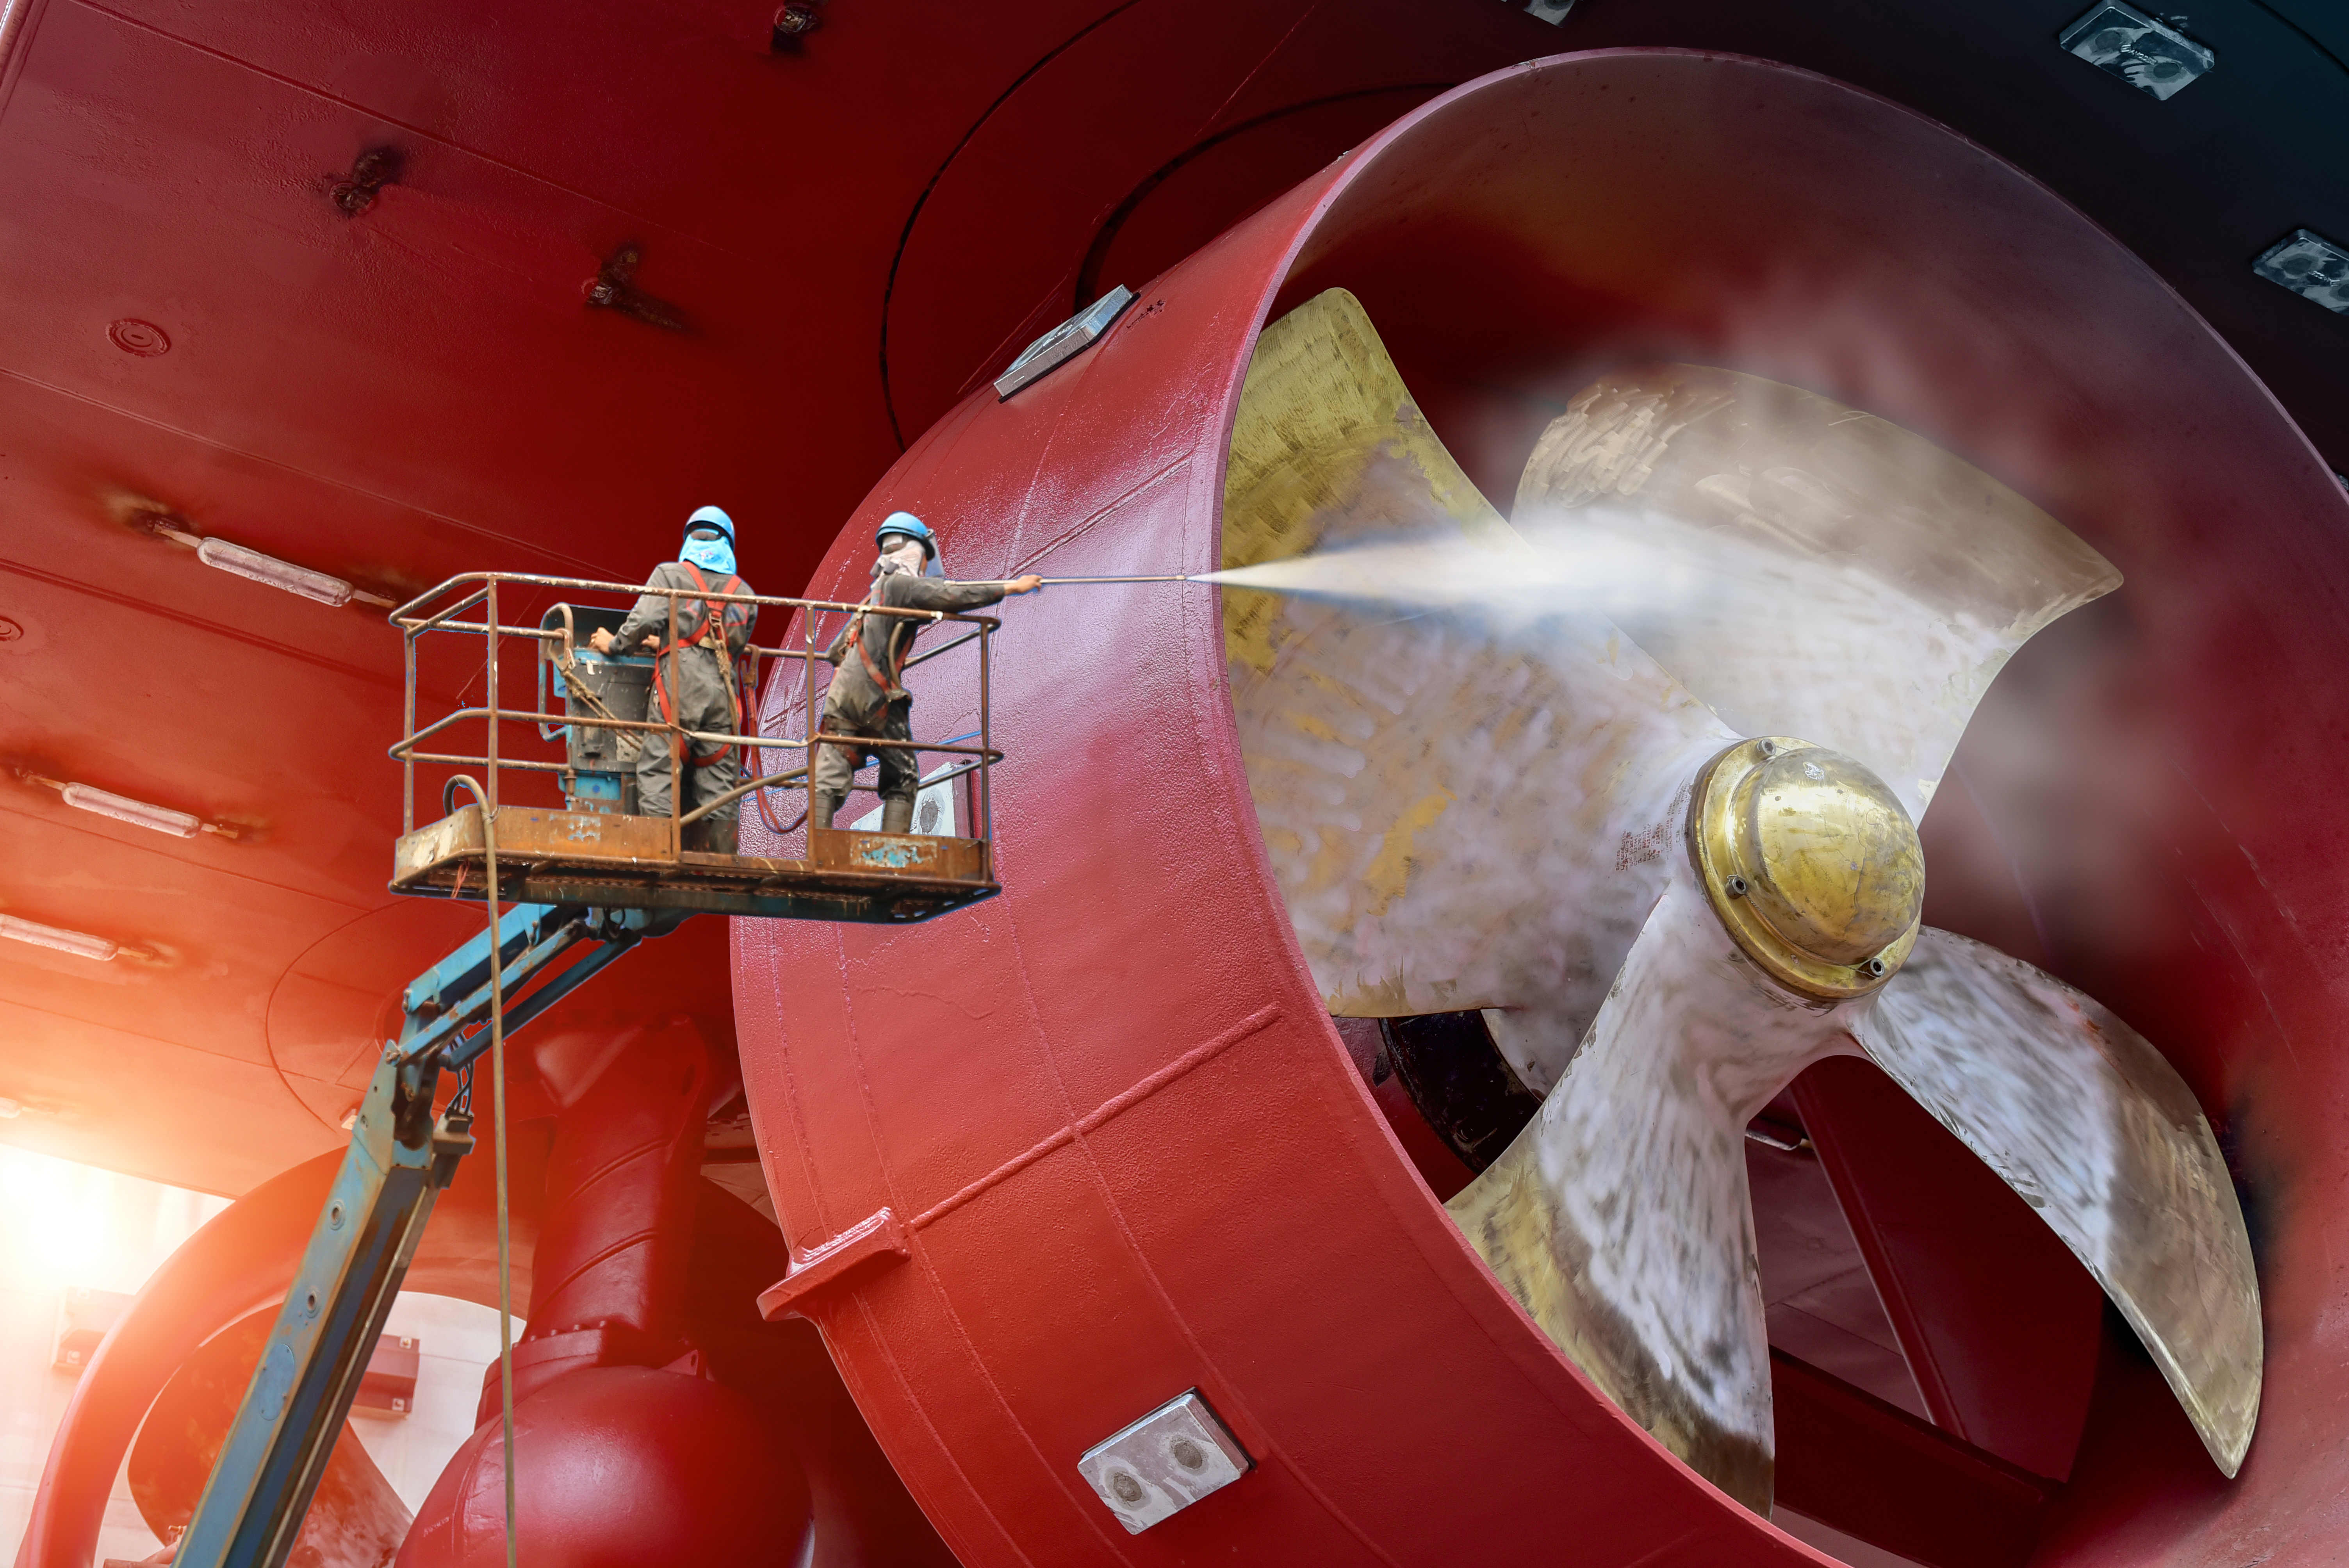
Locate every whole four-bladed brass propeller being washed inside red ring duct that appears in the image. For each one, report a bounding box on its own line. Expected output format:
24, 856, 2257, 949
1224, 289, 2262, 1512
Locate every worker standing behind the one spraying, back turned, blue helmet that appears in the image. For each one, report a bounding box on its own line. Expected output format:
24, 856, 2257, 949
590, 507, 759, 854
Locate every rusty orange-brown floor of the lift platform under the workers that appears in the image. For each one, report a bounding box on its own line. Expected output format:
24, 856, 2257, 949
392, 805, 1001, 923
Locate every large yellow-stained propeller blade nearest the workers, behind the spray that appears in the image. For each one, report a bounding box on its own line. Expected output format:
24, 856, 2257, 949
1224, 289, 1734, 1092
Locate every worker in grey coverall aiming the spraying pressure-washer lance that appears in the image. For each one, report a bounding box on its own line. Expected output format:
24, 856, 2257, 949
808, 512, 1043, 833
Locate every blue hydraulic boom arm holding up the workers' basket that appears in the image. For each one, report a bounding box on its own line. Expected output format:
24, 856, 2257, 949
174, 904, 686, 1568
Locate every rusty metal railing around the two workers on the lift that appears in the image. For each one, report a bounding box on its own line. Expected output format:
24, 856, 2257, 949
390, 573, 1003, 857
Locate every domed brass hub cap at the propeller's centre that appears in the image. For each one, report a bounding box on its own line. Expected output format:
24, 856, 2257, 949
1689, 735, 1924, 1000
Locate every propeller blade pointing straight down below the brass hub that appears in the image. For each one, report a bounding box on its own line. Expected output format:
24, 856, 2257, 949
1447, 854, 1861, 1516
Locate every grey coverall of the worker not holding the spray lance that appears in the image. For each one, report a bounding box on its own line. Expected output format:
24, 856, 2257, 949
613, 561, 759, 854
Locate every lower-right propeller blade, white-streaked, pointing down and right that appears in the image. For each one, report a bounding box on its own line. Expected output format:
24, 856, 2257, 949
1851, 927, 2262, 1477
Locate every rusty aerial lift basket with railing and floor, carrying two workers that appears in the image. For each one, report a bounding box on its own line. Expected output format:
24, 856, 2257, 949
392, 573, 1003, 923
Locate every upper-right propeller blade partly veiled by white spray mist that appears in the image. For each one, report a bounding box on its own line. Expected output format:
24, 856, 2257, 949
1513, 364, 2121, 817
